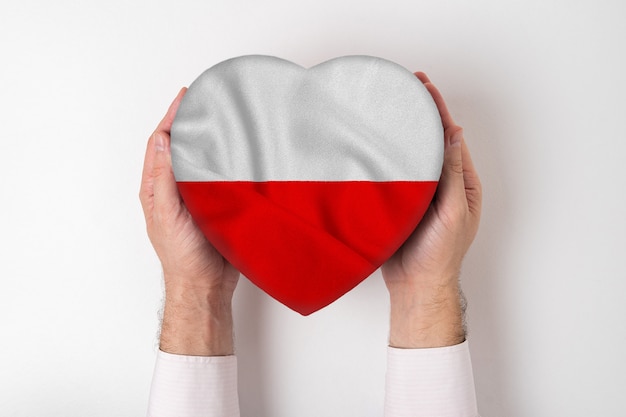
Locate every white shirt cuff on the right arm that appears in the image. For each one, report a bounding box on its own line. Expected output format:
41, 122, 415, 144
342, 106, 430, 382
385, 341, 478, 417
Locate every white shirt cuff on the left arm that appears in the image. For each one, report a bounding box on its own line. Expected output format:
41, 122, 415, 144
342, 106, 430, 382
148, 350, 239, 417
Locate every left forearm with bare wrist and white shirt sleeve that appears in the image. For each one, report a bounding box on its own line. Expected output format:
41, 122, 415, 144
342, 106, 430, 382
148, 276, 239, 417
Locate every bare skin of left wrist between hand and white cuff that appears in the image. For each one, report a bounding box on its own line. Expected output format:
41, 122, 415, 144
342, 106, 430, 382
160, 278, 234, 356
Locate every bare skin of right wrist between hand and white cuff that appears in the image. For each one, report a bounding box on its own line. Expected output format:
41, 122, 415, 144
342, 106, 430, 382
389, 276, 465, 349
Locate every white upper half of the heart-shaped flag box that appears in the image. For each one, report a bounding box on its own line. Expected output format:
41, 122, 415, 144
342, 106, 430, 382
171, 55, 444, 181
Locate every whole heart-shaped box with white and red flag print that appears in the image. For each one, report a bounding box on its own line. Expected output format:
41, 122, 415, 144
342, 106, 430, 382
171, 55, 444, 315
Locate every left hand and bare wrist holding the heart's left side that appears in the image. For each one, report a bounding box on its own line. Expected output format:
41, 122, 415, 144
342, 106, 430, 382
139, 88, 239, 356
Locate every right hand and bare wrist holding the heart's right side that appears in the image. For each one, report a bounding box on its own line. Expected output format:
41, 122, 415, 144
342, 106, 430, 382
382, 72, 482, 348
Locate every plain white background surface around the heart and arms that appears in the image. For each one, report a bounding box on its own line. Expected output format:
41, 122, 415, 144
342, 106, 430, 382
0, 0, 626, 417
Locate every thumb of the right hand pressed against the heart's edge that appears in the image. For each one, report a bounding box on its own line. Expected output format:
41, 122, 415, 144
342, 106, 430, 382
438, 126, 465, 200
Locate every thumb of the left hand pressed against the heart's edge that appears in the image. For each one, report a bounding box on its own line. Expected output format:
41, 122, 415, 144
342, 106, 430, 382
152, 131, 180, 212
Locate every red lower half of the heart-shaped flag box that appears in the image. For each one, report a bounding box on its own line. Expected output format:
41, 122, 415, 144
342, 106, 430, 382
178, 181, 437, 315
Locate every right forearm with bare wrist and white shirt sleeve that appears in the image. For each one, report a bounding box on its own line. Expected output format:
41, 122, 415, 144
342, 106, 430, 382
385, 275, 478, 417
